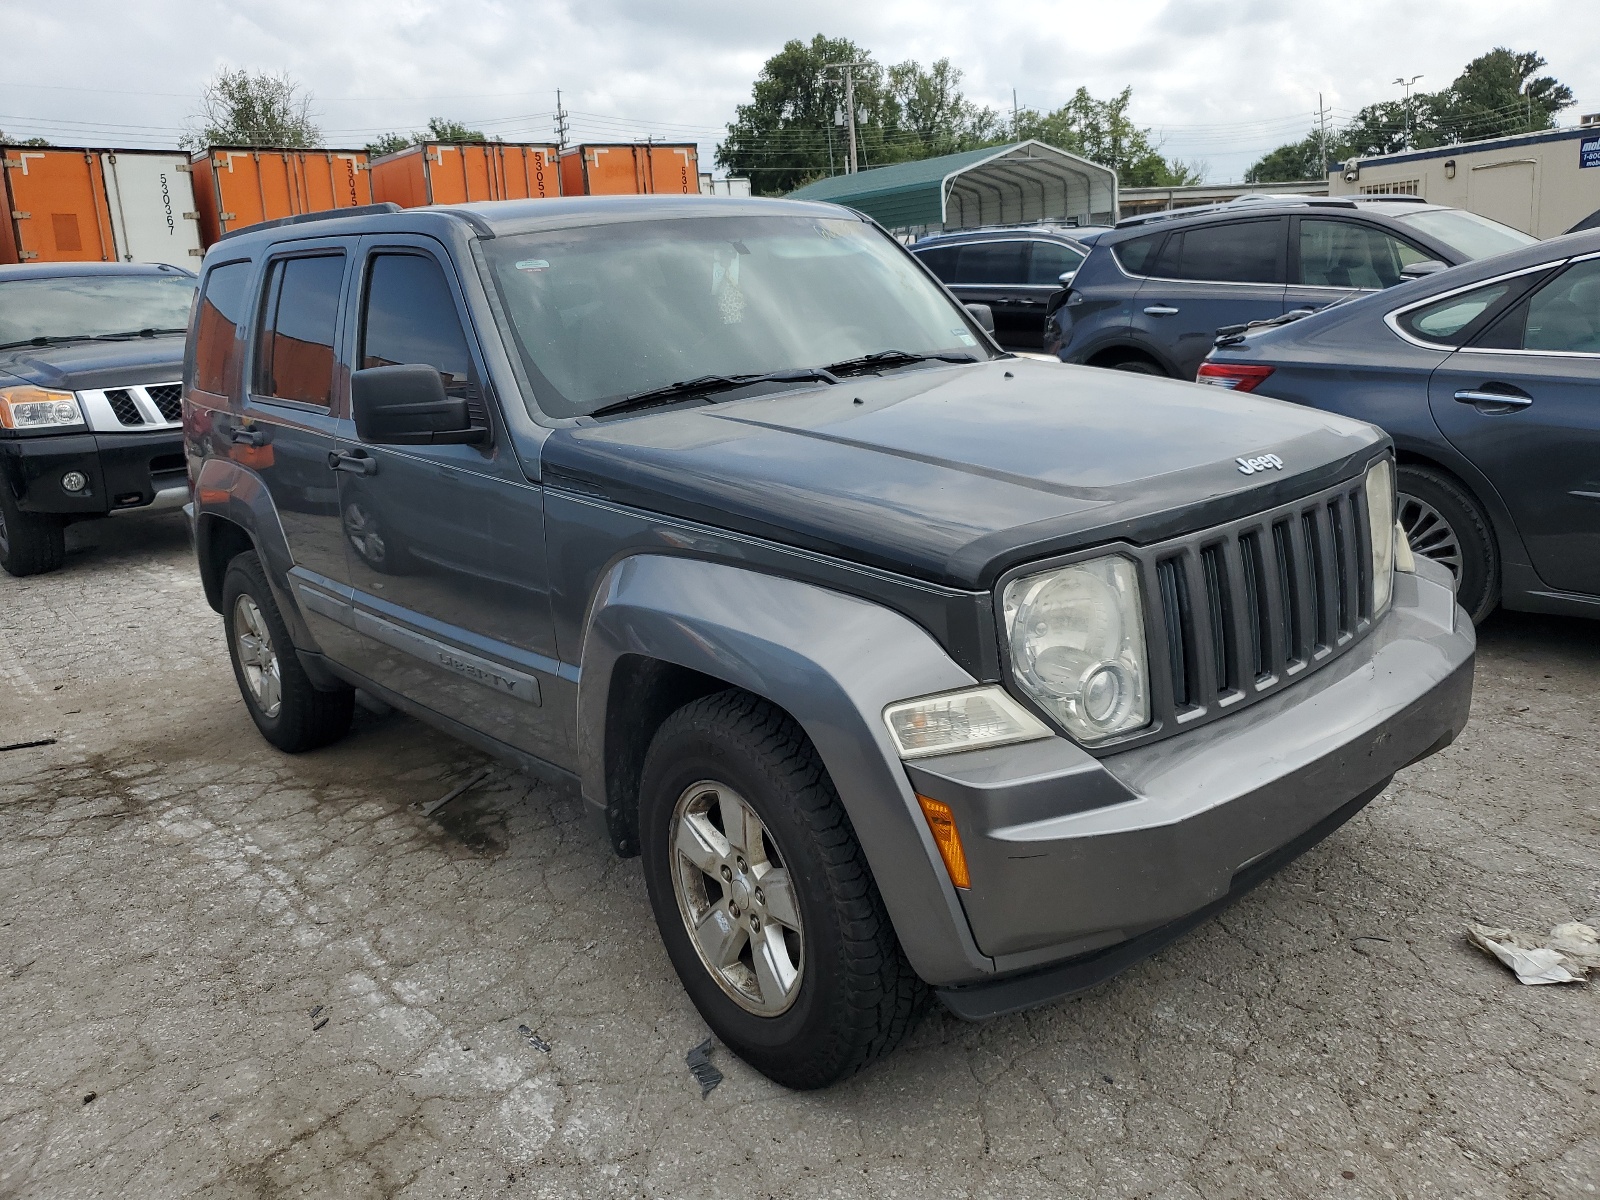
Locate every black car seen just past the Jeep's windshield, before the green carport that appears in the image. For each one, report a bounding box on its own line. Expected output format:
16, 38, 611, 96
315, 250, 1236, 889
910, 226, 1102, 350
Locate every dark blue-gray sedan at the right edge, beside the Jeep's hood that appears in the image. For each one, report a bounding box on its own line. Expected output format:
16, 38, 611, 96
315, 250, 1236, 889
1200, 230, 1600, 621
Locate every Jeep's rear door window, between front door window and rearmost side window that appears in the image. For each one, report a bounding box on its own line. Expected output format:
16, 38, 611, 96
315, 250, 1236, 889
254, 254, 344, 408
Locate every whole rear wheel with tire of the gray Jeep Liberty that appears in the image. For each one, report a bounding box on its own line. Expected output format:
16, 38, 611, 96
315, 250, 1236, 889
222, 550, 355, 754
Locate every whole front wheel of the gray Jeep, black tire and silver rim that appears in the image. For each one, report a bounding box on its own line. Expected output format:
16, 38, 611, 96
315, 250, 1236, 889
638, 690, 928, 1088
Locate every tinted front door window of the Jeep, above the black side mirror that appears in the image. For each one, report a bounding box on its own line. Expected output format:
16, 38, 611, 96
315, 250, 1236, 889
362, 254, 482, 416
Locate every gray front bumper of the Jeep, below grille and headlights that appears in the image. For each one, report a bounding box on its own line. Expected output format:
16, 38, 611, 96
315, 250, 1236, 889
907, 560, 1475, 1018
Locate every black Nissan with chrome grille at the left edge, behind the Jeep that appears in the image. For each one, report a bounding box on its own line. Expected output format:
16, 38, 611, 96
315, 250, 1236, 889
0, 262, 195, 574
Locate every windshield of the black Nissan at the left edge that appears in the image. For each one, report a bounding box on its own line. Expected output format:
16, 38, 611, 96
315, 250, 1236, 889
0, 270, 197, 347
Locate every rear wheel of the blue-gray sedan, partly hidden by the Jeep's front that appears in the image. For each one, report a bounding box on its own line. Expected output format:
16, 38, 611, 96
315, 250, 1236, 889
1395, 466, 1501, 624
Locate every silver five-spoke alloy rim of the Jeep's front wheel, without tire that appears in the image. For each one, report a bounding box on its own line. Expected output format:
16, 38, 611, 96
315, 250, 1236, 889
670, 779, 805, 1016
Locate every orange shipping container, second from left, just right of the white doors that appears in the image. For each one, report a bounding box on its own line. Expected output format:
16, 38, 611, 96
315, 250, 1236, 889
194, 146, 373, 246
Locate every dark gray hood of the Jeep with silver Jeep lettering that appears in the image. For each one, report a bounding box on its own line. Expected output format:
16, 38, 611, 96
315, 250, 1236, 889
542, 358, 1387, 589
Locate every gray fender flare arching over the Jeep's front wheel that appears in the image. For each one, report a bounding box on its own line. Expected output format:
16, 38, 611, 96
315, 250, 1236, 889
578, 554, 994, 984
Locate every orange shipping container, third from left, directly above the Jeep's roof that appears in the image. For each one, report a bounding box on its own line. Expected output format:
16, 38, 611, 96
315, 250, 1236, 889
371, 142, 562, 208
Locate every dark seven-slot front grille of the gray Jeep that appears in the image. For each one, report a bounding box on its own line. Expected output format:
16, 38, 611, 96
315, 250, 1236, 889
1138, 480, 1373, 731
